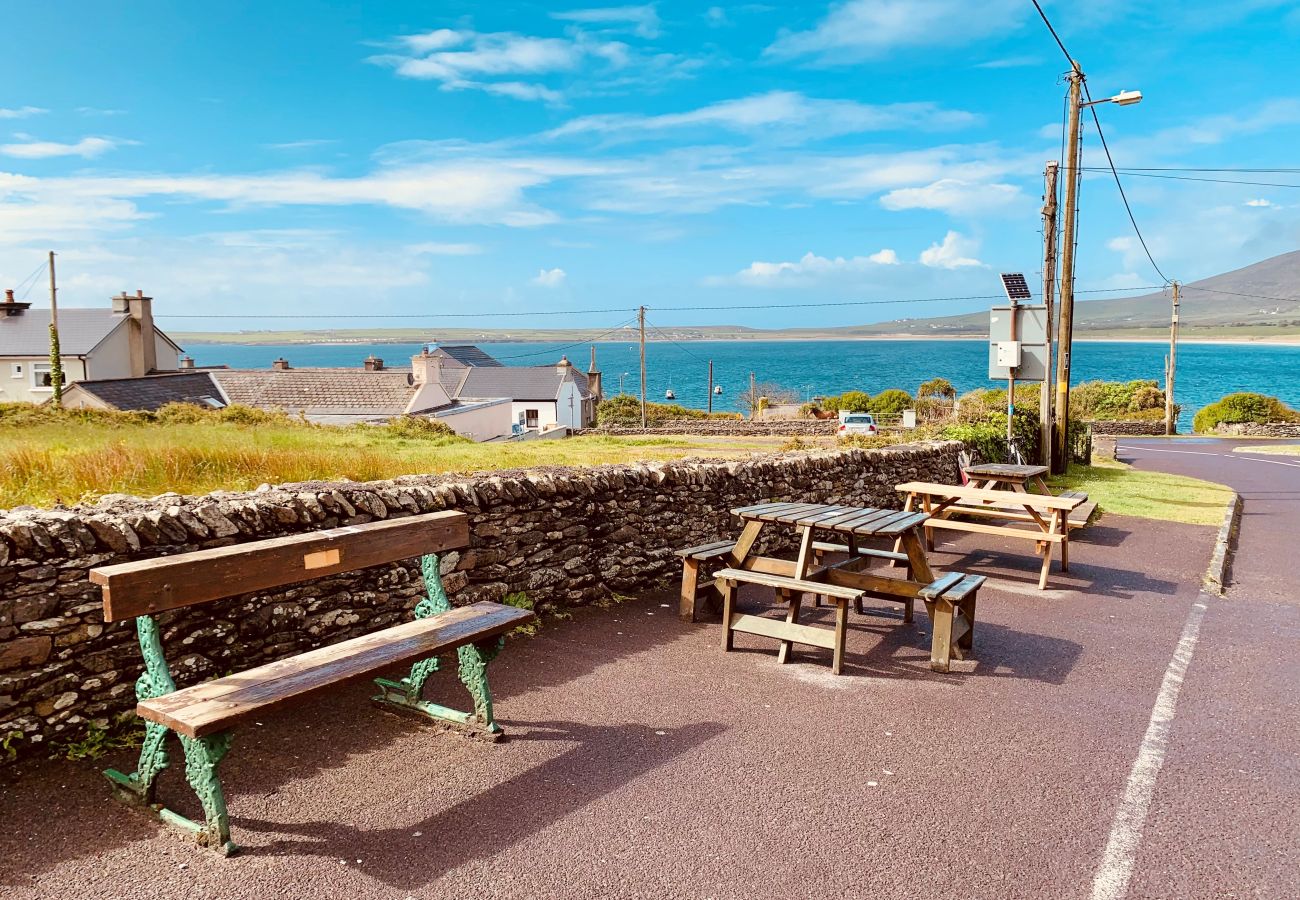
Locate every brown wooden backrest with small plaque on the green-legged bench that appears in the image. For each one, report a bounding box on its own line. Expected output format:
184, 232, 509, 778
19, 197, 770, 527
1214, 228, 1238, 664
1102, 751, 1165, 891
90, 510, 469, 622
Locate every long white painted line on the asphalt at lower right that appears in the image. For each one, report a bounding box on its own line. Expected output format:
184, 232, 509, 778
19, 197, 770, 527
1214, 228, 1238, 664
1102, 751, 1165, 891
1092, 600, 1208, 900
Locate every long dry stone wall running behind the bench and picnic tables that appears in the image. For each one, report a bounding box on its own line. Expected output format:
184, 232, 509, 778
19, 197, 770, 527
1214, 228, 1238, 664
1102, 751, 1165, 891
0, 442, 961, 766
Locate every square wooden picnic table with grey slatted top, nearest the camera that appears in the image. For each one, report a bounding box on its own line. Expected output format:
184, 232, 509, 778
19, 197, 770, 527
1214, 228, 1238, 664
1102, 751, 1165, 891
679, 502, 984, 675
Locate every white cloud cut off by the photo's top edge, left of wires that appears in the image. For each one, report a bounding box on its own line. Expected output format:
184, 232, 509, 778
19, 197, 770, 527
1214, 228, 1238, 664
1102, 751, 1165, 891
767, 0, 1027, 64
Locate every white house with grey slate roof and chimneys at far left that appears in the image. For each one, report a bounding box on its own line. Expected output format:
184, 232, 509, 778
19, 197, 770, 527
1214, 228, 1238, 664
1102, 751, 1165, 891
0, 290, 181, 403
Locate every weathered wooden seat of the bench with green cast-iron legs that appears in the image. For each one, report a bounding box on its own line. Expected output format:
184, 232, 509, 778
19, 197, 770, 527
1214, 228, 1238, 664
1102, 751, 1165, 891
135, 600, 534, 737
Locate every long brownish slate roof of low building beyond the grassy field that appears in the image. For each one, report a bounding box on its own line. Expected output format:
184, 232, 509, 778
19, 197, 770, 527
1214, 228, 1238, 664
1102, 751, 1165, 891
212, 369, 415, 416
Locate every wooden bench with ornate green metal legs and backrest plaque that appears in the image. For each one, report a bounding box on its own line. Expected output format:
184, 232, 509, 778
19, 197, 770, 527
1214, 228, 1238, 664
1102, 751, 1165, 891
90, 511, 534, 856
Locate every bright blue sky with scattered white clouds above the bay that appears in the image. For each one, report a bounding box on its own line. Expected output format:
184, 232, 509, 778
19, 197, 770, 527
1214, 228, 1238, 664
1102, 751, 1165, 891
0, 0, 1300, 333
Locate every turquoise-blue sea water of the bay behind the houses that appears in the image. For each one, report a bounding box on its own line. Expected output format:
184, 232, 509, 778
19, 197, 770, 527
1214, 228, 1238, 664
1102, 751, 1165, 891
186, 341, 1300, 430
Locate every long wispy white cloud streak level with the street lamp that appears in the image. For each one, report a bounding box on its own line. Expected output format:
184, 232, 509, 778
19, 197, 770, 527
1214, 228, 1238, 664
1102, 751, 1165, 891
547, 91, 979, 142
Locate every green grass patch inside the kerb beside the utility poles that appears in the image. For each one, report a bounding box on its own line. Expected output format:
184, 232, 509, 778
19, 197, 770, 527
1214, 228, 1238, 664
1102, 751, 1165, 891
1048, 462, 1232, 525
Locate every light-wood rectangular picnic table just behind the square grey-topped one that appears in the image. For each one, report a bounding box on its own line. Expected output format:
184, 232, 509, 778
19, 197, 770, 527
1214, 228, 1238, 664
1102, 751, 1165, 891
896, 481, 1088, 590
